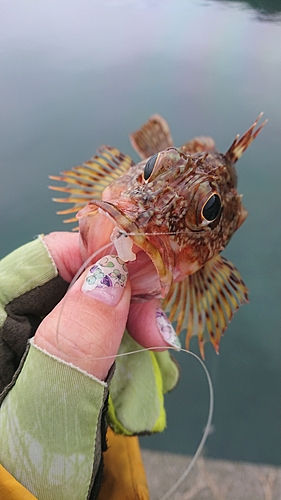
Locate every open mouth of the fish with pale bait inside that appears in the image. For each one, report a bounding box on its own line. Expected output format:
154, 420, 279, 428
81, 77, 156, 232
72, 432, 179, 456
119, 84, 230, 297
77, 200, 173, 301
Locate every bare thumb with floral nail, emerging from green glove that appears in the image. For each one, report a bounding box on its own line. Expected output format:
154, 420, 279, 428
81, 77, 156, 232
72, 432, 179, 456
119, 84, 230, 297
34, 255, 131, 380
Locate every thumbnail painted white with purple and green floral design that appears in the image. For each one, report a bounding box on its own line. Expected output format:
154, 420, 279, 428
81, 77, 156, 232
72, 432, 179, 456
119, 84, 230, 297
82, 255, 128, 306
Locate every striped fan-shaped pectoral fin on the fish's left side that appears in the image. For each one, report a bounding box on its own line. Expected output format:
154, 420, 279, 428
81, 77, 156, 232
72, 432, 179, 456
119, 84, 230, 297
49, 146, 134, 222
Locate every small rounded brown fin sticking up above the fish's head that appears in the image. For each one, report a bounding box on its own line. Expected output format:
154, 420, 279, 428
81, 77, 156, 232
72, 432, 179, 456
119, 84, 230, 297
130, 115, 174, 160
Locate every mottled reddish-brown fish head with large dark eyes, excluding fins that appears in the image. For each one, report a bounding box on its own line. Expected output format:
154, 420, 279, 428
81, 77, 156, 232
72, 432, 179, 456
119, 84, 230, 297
77, 147, 247, 297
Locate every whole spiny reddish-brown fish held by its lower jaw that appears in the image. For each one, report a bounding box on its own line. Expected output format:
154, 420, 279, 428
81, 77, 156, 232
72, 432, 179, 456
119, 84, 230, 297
50, 113, 267, 359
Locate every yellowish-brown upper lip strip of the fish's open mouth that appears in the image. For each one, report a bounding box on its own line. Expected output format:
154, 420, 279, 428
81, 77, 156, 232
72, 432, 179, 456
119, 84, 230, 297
87, 200, 173, 299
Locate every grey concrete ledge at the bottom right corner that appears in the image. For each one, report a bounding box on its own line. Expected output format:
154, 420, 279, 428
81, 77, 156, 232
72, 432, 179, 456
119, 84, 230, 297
142, 450, 281, 500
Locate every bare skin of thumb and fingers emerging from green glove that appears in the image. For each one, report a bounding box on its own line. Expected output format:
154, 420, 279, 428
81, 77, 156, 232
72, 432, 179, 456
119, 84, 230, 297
34, 232, 179, 380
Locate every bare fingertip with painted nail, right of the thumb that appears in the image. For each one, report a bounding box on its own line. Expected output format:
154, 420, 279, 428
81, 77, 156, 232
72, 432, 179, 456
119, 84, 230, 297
127, 299, 181, 350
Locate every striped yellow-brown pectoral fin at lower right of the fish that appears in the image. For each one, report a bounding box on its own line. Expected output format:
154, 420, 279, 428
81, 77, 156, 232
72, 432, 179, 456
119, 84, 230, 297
163, 255, 248, 358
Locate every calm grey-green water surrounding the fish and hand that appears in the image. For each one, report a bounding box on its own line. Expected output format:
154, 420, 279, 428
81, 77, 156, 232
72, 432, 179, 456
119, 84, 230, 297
0, 0, 281, 464
